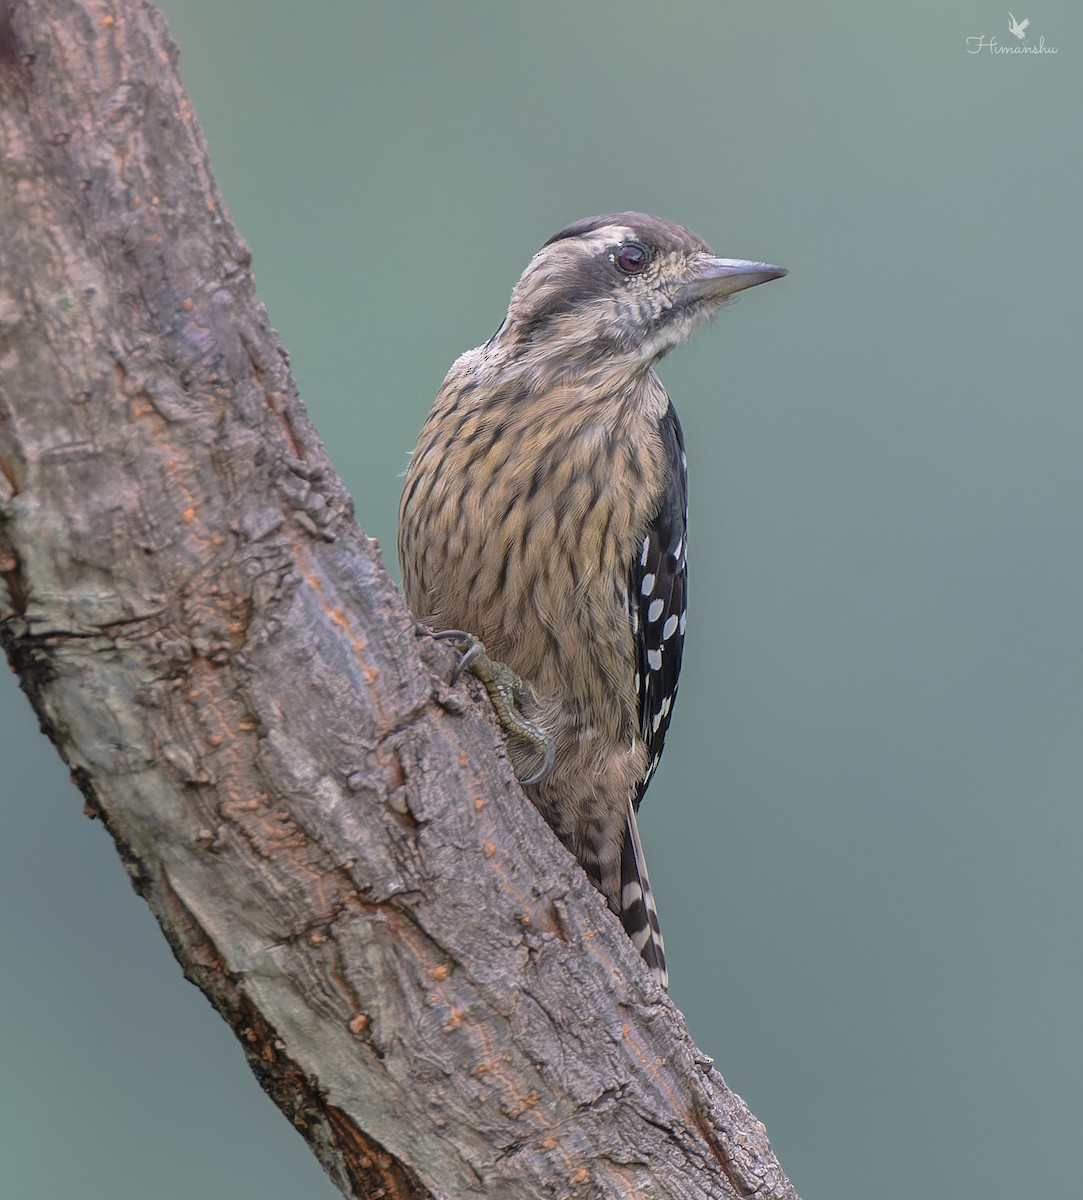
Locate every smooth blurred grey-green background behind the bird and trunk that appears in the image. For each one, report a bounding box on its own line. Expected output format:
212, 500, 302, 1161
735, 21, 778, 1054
0, 0, 1083, 1200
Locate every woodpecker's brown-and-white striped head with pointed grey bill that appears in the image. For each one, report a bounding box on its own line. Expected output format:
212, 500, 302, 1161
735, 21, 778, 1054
498, 212, 786, 367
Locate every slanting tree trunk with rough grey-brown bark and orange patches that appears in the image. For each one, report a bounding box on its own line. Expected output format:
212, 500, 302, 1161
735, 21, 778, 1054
0, 0, 796, 1200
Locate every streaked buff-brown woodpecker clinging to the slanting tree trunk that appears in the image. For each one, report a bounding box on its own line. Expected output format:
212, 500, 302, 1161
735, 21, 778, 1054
399, 212, 786, 986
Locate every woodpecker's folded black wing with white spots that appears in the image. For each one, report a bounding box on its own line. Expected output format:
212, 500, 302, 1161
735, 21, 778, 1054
628, 406, 688, 809
